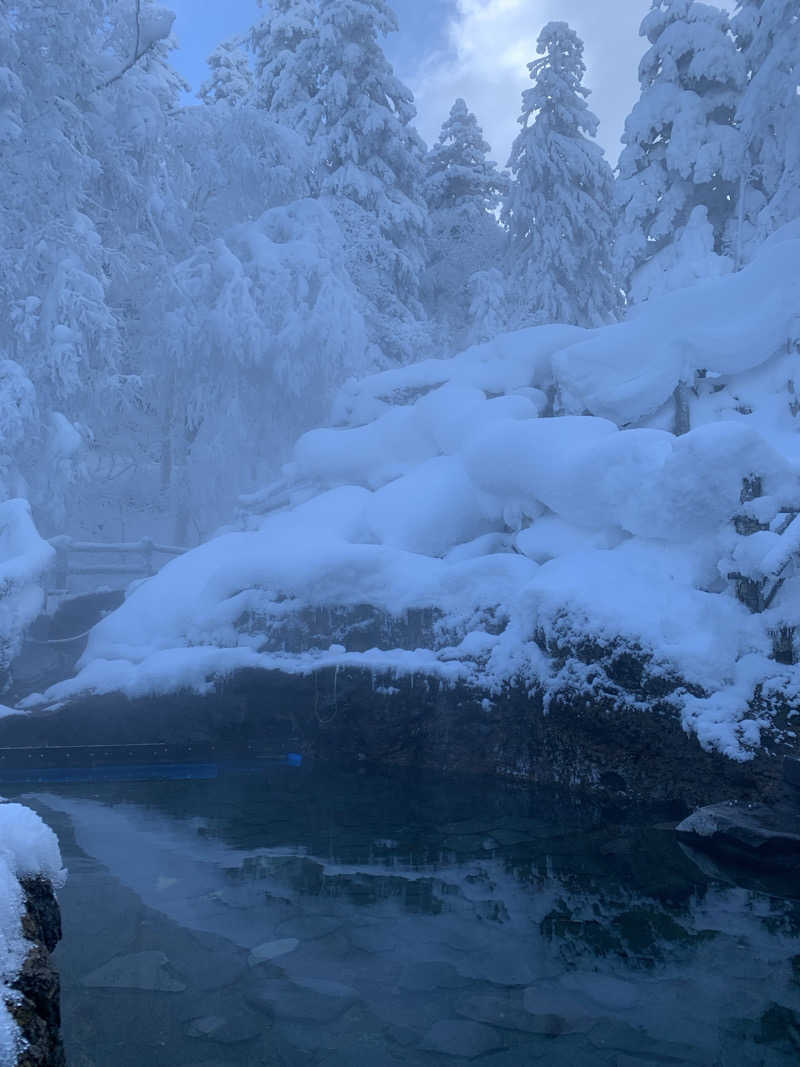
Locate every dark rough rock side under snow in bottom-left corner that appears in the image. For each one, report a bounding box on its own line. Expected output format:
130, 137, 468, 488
9, 877, 66, 1067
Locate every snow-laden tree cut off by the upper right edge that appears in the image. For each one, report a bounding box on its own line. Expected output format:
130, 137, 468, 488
731, 0, 800, 265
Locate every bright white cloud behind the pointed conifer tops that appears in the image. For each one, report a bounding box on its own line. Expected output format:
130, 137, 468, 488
407, 0, 649, 165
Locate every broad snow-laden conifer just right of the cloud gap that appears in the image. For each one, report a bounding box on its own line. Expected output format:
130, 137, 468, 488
615, 0, 745, 301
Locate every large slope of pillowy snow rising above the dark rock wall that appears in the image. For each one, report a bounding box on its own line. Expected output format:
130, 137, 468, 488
31, 224, 800, 759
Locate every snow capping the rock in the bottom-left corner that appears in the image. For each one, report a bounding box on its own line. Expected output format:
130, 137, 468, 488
0, 797, 66, 1064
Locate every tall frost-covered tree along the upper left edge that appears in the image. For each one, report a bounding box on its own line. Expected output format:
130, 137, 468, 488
0, 0, 181, 525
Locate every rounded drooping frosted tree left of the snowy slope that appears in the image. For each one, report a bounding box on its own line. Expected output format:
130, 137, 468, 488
152, 200, 367, 544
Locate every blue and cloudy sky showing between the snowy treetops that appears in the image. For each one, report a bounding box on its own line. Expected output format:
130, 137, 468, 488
166, 0, 730, 165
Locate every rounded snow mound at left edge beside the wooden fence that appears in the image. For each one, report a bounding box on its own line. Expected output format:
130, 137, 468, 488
0, 499, 54, 674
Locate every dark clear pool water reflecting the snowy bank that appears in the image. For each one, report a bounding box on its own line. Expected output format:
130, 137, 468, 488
17, 767, 800, 1067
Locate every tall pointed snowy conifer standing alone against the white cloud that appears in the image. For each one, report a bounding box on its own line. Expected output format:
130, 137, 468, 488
502, 22, 619, 327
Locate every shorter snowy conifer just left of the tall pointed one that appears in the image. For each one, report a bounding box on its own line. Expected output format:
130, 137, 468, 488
425, 98, 507, 350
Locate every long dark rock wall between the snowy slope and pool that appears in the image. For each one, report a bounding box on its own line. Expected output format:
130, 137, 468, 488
0, 668, 796, 810
